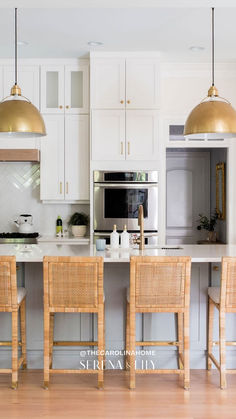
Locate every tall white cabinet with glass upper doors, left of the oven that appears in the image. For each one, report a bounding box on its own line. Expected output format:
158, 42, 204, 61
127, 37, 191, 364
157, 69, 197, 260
40, 60, 89, 202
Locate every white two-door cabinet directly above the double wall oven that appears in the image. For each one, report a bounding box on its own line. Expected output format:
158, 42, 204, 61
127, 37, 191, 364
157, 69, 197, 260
92, 110, 158, 161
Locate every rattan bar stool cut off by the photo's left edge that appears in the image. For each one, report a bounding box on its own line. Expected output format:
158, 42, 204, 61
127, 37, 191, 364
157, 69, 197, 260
0, 256, 27, 389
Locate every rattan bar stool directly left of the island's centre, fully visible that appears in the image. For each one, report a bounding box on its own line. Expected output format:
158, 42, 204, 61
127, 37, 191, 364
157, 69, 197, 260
43, 256, 105, 389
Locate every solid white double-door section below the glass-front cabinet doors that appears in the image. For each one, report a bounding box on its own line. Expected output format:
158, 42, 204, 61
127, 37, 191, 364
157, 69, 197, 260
40, 115, 89, 202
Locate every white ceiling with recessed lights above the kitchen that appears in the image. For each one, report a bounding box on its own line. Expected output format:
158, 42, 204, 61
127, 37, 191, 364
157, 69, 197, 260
0, 0, 236, 62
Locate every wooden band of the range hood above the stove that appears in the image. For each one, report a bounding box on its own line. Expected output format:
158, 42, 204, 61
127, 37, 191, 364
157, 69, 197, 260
0, 148, 40, 162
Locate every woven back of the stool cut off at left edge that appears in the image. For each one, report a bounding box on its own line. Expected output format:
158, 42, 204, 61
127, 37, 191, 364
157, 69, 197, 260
0, 256, 17, 311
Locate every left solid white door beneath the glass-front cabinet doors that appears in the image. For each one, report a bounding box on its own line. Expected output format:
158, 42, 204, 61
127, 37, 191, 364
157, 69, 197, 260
40, 115, 64, 200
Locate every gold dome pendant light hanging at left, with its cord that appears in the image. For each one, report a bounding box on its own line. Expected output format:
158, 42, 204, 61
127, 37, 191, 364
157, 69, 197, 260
0, 9, 46, 137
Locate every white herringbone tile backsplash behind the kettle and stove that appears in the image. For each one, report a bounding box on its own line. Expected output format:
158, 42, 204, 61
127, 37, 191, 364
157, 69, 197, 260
0, 162, 89, 235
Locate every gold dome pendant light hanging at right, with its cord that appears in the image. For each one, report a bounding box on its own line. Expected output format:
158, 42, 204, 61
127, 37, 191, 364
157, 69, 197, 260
184, 8, 236, 140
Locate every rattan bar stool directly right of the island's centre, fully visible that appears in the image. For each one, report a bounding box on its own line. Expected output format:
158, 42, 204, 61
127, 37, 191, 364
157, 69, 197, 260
126, 256, 191, 390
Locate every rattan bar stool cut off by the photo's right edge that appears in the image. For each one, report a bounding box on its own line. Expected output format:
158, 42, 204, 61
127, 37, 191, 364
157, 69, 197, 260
208, 257, 236, 389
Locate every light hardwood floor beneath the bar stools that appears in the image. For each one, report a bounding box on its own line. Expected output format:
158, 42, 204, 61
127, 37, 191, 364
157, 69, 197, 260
0, 370, 236, 419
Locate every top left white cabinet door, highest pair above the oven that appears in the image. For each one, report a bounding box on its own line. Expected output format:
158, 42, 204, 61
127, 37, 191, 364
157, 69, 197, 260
90, 58, 125, 109
